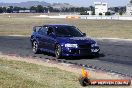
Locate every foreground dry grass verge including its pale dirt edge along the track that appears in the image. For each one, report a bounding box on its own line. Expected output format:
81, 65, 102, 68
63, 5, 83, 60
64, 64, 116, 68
0, 55, 131, 88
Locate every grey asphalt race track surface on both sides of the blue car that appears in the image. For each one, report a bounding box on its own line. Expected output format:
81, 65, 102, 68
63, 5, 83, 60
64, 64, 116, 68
0, 36, 132, 77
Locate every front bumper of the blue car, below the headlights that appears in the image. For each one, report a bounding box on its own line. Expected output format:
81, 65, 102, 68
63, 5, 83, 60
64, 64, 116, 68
62, 46, 100, 56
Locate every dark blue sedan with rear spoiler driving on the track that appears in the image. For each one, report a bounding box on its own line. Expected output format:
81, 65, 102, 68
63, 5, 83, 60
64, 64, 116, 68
30, 24, 100, 58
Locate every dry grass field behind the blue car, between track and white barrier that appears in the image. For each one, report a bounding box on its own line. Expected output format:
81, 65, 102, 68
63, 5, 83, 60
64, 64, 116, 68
0, 14, 132, 39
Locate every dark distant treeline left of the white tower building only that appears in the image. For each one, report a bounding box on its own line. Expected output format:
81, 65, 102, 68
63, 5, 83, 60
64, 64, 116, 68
0, 5, 94, 13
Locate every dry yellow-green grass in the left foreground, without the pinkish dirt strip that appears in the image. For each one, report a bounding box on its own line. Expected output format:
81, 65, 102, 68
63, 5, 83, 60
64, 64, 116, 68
0, 58, 81, 88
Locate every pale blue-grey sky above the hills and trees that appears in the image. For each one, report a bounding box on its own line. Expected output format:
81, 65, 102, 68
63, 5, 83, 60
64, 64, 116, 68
0, 0, 129, 6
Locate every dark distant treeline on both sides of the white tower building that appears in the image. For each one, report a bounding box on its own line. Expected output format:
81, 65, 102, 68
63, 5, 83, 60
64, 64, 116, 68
0, 5, 126, 14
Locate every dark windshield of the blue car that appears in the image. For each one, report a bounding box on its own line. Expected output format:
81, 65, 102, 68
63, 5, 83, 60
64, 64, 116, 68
55, 26, 83, 37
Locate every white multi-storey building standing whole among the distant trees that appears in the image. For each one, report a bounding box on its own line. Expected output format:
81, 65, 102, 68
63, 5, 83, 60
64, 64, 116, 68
94, 2, 108, 15
